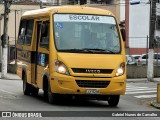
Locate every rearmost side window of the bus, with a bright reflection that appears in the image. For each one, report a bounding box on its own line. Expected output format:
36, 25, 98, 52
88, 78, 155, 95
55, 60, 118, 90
17, 20, 26, 44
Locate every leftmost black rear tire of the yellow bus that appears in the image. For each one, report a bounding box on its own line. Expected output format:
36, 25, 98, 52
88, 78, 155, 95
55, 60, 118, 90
22, 74, 31, 95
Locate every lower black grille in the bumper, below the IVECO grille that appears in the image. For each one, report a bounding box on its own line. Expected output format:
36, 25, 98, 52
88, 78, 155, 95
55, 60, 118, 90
76, 80, 110, 88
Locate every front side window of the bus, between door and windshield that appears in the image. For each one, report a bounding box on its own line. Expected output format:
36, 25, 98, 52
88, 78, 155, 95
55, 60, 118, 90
40, 21, 49, 49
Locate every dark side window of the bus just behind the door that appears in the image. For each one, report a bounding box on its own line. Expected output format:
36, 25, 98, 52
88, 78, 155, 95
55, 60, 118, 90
24, 20, 34, 45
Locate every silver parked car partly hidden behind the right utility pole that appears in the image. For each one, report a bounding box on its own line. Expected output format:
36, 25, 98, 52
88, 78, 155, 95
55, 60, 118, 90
137, 53, 160, 65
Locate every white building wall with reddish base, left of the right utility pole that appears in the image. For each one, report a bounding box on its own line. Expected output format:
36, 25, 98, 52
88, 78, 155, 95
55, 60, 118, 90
129, 0, 150, 54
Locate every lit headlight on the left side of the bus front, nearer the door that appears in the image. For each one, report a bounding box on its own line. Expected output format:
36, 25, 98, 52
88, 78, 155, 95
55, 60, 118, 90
54, 60, 69, 75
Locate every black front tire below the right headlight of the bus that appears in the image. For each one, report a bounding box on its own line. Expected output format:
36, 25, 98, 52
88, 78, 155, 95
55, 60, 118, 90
108, 95, 120, 107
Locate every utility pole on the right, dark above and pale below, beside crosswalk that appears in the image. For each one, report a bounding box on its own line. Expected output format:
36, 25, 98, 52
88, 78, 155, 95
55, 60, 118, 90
147, 0, 156, 81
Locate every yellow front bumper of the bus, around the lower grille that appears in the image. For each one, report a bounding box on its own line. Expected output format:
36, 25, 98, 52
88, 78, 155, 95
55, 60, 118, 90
50, 72, 126, 95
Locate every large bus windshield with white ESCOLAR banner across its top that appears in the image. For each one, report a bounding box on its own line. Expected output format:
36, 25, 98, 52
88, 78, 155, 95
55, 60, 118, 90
53, 14, 121, 54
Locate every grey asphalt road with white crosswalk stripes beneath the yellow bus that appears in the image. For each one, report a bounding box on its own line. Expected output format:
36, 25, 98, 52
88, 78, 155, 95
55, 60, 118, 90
0, 80, 160, 120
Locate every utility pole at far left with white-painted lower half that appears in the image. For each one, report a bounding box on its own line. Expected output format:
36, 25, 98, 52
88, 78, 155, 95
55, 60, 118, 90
1, 0, 12, 78
